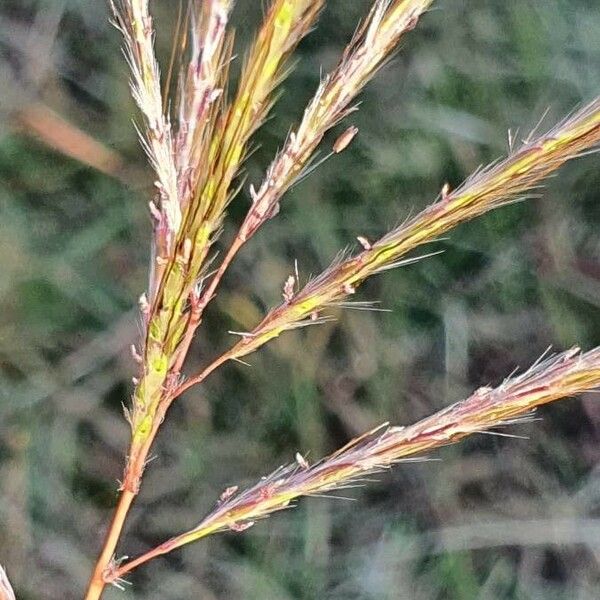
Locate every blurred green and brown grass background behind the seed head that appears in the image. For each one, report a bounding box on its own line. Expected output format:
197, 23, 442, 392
0, 0, 600, 600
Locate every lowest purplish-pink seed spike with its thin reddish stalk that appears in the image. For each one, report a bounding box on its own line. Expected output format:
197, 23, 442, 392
109, 348, 600, 581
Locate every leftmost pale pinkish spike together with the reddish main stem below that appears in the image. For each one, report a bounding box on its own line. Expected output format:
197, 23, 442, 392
86, 0, 182, 600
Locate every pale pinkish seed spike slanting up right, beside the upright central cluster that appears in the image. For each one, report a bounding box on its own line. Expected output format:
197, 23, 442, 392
240, 0, 433, 240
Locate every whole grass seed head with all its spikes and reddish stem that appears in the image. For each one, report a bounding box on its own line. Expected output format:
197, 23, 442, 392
56, 0, 600, 600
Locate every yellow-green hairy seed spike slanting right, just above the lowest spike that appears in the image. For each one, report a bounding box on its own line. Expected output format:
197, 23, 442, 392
177, 98, 600, 393
